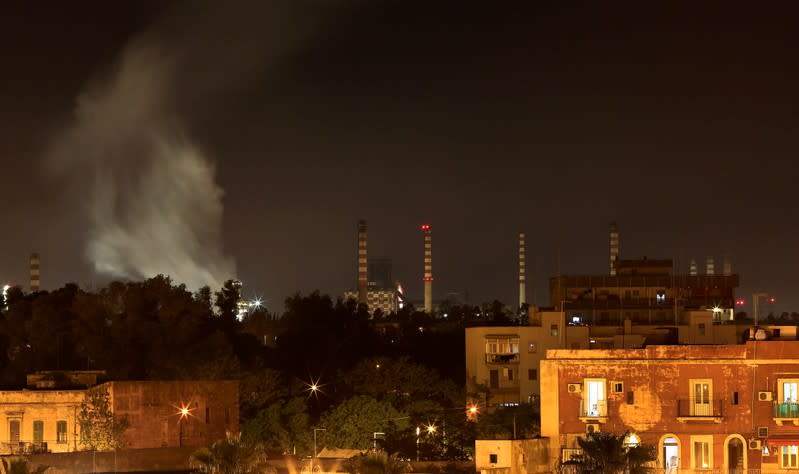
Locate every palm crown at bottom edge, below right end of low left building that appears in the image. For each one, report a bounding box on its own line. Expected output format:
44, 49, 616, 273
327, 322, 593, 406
189, 433, 276, 474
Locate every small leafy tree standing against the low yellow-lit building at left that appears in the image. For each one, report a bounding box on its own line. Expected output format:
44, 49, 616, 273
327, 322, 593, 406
78, 386, 130, 451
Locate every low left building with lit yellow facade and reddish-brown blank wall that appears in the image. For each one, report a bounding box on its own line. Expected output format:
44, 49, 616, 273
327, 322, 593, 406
0, 371, 238, 454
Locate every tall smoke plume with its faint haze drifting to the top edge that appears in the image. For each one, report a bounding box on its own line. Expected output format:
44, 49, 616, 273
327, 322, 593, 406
49, 2, 330, 289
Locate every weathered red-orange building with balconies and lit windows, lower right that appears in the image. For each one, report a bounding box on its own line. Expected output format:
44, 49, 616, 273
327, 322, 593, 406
541, 340, 799, 472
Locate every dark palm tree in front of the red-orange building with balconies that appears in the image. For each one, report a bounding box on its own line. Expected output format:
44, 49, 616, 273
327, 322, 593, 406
576, 432, 657, 474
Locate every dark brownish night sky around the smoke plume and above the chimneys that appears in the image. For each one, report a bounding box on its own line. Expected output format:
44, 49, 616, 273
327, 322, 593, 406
0, 1, 799, 312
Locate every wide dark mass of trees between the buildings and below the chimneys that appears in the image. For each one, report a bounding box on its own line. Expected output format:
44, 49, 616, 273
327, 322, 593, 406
0, 276, 537, 459
